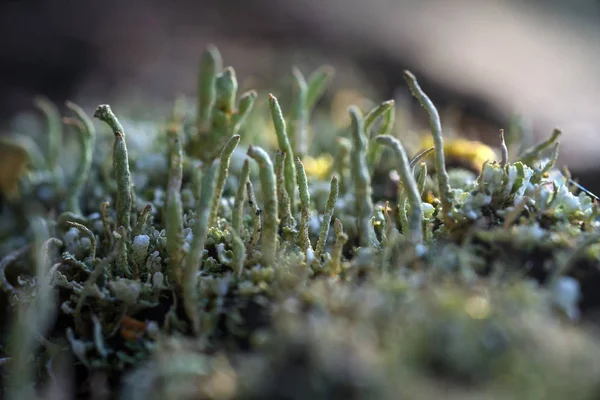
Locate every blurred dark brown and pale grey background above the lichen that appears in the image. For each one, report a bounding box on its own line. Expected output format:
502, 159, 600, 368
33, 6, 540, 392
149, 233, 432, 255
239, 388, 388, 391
0, 0, 600, 192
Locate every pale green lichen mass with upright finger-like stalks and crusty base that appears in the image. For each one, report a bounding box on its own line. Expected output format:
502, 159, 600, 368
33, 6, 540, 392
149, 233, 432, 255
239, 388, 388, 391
0, 47, 600, 400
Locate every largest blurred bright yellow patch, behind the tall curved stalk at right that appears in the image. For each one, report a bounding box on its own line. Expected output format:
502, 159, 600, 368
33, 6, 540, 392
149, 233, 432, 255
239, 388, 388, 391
419, 135, 498, 173
